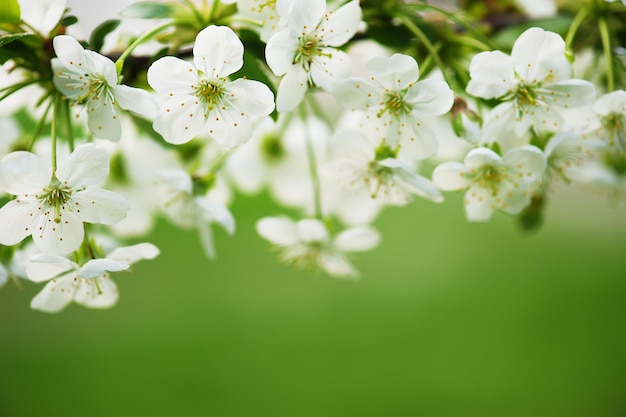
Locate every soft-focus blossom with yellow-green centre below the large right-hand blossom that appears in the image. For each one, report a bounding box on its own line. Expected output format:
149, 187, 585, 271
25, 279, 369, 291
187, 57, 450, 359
433, 145, 546, 221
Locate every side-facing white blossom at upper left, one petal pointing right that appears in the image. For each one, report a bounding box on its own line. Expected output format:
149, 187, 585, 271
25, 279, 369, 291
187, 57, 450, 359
52, 35, 156, 140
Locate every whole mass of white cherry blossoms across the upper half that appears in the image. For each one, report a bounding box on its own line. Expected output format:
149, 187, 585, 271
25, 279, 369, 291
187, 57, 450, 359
0, 0, 626, 312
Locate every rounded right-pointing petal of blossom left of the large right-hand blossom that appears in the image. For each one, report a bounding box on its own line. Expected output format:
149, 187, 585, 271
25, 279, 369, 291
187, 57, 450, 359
405, 79, 454, 116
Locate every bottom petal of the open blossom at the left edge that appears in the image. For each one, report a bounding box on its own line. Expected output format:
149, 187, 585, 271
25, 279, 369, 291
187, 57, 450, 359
33, 211, 85, 255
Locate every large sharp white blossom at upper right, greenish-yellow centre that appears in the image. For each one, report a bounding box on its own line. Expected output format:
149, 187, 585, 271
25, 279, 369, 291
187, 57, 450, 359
467, 27, 595, 142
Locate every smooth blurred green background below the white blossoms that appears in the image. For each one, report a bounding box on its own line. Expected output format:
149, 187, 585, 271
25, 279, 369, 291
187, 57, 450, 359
0, 189, 626, 417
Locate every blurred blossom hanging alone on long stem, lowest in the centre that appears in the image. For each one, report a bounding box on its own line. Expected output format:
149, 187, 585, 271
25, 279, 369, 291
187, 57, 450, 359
256, 217, 380, 277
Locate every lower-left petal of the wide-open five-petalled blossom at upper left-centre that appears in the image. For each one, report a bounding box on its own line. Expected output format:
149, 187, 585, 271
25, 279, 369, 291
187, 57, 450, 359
152, 96, 208, 145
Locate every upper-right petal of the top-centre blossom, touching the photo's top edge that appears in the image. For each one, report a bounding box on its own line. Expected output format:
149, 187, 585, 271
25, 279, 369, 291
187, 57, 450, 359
317, 0, 361, 46
